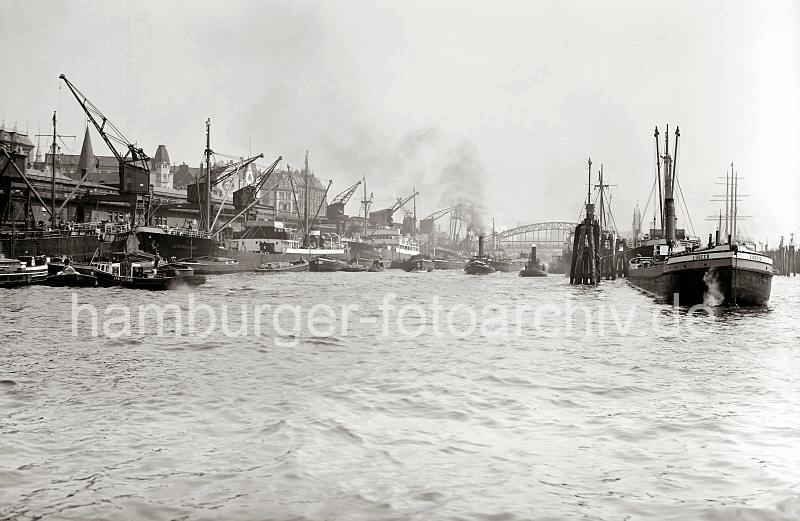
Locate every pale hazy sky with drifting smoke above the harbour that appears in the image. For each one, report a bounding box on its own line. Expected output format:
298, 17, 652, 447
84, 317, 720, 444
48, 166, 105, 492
0, 0, 800, 241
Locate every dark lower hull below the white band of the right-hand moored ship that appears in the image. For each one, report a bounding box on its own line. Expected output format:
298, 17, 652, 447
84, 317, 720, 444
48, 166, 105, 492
630, 266, 772, 306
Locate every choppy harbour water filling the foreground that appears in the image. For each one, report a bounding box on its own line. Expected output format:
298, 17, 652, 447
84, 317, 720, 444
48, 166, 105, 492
0, 270, 800, 520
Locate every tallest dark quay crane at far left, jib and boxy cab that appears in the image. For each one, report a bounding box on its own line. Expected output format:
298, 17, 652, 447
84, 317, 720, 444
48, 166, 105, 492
59, 74, 150, 195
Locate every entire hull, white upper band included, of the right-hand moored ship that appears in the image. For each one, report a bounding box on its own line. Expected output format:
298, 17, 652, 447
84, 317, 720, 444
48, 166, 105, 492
629, 248, 772, 306
